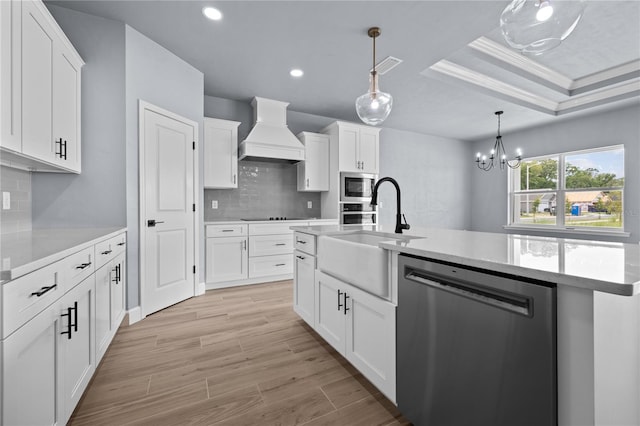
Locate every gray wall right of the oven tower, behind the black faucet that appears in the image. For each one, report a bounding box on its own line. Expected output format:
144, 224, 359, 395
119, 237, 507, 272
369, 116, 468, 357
378, 128, 472, 229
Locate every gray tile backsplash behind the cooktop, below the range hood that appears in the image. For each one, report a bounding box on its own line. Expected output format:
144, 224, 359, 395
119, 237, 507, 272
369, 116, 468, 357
204, 161, 320, 221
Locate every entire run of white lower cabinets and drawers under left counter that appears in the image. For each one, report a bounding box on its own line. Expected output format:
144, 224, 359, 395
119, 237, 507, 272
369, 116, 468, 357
0, 233, 126, 426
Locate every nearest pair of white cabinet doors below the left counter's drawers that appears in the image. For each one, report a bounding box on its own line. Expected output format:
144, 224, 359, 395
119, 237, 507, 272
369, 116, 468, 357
2, 275, 96, 425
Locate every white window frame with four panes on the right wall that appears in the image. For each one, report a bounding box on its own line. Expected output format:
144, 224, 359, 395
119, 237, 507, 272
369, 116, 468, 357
504, 144, 630, 236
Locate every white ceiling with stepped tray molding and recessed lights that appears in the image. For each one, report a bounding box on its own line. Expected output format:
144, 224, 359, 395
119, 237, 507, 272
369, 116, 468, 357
46, 0, 640, 140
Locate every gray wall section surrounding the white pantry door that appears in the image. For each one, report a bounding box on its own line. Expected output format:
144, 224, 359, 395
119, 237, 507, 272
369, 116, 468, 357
125, 26, 204, 308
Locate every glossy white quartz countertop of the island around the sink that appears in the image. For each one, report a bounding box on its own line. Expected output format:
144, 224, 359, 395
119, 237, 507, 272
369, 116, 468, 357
292, 225, 640, 296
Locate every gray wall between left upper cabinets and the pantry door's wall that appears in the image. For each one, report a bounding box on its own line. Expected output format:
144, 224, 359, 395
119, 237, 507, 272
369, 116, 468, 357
32, 5, 127, 228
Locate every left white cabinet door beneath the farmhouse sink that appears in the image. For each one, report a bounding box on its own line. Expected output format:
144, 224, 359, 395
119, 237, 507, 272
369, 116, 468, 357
315, 271, 346, 354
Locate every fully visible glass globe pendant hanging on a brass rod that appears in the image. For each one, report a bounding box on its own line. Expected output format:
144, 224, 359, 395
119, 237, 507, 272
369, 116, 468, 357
356, 27, 393, 126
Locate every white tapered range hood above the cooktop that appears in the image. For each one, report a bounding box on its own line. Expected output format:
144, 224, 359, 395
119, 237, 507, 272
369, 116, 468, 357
238, 97, 304, 163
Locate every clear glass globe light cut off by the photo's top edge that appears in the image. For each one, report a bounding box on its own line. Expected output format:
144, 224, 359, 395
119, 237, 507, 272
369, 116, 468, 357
500, 0, 585, 55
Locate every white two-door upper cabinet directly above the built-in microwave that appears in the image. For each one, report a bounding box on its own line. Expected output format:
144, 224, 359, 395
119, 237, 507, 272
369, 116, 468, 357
323, 121, 380, 174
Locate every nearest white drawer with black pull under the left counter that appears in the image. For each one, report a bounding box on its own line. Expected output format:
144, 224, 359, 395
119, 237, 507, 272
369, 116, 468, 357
2, 262, 65, 338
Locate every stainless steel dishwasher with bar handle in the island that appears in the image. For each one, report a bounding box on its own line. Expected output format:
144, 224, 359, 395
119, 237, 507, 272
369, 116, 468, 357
396, 255, 557, 426
